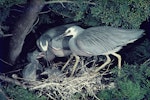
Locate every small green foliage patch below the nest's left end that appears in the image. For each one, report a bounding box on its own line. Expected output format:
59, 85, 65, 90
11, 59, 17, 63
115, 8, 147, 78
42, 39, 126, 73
5, 85, 46, 100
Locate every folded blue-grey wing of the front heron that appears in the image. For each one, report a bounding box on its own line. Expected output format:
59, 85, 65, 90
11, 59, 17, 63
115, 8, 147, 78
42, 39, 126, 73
76, 26, 143, 55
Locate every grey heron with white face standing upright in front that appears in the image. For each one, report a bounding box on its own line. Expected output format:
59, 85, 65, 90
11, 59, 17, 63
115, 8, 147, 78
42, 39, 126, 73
59, 26, 144, 76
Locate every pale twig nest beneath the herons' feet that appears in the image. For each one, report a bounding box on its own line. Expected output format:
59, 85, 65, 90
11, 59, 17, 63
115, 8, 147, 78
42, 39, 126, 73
21, 56, 114, 100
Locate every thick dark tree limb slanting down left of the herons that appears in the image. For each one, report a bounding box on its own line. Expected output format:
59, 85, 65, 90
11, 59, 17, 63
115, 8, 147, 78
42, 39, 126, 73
8, 0, 44, 64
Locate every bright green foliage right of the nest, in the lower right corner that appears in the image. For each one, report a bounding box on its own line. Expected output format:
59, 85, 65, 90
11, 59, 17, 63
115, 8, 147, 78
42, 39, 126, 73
98, 62, 150, 100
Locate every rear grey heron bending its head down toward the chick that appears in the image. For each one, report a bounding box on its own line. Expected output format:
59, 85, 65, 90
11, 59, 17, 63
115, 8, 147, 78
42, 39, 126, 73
36, 24, 75, 61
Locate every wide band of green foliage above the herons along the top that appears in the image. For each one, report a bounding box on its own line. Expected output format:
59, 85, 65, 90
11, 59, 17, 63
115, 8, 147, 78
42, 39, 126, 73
49, 0, 150, 28
